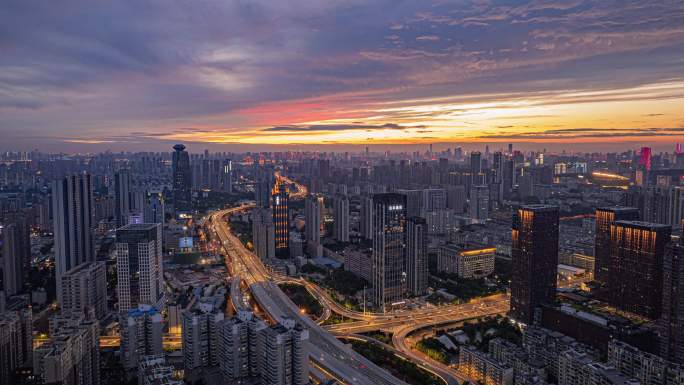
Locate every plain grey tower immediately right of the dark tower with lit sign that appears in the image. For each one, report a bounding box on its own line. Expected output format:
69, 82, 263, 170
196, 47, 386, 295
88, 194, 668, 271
406, 217, 428, 295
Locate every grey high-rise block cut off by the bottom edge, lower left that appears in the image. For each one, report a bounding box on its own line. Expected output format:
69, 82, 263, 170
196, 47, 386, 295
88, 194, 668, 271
33, 317, 100, 385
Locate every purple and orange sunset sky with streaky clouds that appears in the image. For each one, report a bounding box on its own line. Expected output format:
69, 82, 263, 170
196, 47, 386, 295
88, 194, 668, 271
0, 0, 684, 152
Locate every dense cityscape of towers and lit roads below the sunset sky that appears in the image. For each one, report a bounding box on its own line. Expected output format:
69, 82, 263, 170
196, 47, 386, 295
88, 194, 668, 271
0, 144, 684, 385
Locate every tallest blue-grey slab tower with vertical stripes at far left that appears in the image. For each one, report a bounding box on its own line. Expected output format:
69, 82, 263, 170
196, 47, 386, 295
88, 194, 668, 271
52, 174, 95, 304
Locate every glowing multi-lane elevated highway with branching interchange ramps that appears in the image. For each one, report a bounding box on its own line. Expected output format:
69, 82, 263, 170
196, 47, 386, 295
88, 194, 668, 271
209, 176, 508, 385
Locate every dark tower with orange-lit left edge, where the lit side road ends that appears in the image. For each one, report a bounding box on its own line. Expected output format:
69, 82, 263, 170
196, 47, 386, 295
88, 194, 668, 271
510, 205, 558, 324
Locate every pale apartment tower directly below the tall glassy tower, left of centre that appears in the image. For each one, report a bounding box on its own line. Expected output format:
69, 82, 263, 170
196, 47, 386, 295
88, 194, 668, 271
119, 305, 164, 370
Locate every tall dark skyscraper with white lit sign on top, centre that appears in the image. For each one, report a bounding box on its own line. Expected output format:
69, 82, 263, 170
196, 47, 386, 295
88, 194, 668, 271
372, 193, 407, 312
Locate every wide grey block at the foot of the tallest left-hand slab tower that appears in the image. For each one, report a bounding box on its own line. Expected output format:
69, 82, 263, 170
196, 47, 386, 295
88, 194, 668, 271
61, 261, 107, 320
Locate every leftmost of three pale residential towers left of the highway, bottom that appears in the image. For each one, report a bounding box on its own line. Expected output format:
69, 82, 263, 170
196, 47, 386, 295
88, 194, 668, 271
181, 295, 225, 381
